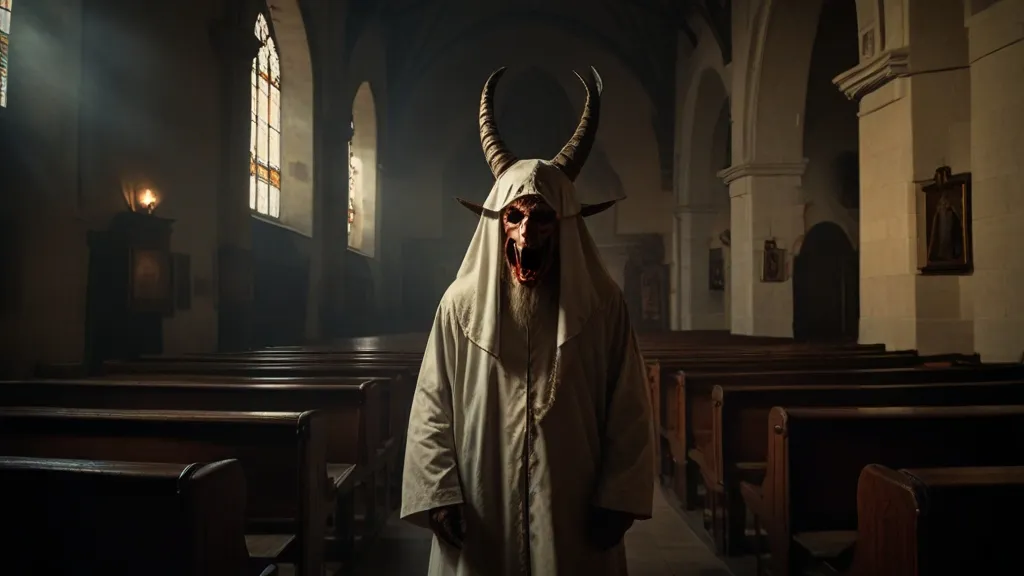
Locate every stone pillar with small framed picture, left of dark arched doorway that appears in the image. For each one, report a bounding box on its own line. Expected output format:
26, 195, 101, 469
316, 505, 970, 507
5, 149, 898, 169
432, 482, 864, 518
719, 161, 807, 337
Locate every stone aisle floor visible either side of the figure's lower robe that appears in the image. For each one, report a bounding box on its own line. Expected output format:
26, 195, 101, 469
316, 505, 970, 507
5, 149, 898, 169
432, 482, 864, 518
348, 489, 732, 576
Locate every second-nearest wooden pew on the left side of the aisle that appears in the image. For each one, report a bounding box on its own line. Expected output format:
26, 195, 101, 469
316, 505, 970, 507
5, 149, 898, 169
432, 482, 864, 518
0, 407, 330, 576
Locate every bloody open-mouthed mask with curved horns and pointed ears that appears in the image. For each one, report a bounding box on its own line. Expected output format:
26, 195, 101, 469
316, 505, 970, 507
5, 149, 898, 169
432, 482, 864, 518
457, 68, 615, 288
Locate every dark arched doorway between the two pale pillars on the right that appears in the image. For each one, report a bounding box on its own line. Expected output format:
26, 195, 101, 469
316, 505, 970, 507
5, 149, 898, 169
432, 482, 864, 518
793, 222, 860, 342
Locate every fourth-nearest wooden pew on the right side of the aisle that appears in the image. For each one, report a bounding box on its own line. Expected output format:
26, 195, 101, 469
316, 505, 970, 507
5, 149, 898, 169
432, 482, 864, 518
662, 359, 1024, 509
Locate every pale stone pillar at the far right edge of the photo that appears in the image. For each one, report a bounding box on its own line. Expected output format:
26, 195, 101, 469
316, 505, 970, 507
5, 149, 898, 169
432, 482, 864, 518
967, 0, 1024, 362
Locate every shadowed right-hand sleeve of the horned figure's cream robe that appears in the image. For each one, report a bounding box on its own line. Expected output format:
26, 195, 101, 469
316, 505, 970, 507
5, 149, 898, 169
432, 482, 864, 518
594, 293, 654, 520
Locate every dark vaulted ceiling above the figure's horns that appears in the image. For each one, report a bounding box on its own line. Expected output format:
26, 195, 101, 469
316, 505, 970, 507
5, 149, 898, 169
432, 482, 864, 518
346, 0, 729, 186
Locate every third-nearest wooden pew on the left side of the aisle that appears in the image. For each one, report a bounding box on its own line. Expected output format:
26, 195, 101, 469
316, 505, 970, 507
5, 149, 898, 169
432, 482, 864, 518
0, 379, 382, 559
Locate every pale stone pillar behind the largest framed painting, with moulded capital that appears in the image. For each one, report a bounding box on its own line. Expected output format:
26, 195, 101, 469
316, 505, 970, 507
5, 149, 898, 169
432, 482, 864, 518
834, 42, 974, 354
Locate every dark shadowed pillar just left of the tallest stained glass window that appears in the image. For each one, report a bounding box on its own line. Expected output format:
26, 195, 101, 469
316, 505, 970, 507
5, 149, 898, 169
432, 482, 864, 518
211, 17, 260, 352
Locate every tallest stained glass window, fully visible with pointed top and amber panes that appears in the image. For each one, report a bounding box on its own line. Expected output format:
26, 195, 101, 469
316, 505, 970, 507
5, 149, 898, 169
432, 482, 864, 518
253, 15, 281, 218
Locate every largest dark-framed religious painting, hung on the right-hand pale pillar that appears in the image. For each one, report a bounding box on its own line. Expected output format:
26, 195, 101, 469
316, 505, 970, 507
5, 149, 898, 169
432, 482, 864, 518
921, 166, 974, 275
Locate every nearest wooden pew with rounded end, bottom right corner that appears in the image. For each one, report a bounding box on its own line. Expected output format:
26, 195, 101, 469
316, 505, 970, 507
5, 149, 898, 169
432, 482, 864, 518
847, 464, 1024, 576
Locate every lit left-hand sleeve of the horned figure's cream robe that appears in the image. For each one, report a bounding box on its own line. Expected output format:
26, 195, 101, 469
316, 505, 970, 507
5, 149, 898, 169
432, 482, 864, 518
400, 299, 463, 527
